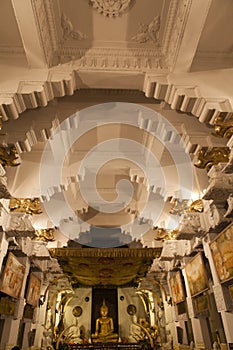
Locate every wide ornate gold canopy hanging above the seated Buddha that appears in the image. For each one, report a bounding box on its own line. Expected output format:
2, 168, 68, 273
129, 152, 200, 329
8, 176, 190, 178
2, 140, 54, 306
50, 248, 162, 288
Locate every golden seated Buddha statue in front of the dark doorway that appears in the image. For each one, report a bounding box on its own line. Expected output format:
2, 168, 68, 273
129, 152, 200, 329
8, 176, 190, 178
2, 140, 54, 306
91, 300, 118, 343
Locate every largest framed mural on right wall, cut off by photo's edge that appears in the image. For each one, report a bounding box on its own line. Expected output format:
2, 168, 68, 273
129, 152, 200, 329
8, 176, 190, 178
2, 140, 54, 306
210, 225, 233, 282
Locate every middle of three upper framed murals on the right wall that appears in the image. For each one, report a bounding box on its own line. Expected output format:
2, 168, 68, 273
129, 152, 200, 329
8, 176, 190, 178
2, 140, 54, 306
185, 253, 209, 296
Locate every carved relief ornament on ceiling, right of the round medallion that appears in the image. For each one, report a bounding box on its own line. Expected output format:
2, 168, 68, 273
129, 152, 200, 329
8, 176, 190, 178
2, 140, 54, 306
131, 16, 160, 44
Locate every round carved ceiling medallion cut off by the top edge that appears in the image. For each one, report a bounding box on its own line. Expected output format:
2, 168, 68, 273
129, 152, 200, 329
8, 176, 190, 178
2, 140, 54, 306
90, 0, 131, 17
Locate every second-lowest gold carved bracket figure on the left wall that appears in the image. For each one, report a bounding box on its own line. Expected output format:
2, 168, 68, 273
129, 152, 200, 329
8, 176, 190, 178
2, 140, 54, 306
9, 198, 42, 215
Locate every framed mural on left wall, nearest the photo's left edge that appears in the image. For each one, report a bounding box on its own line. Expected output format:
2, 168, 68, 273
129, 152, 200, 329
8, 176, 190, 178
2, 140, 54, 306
0, 253, 25, 299
